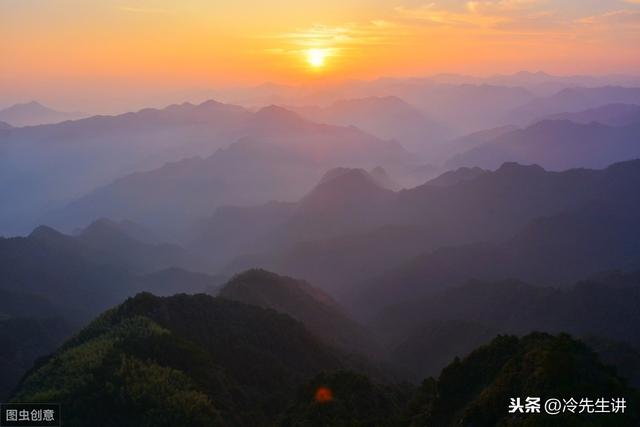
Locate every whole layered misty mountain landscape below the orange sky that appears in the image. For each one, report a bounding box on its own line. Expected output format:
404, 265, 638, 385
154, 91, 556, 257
6, 75, 640, 427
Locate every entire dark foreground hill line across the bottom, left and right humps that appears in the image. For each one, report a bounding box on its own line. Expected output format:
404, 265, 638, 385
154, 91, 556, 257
12, 294, 638, 427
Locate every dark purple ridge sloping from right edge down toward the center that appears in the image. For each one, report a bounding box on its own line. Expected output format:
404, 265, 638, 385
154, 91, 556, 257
351, 187, 640, 318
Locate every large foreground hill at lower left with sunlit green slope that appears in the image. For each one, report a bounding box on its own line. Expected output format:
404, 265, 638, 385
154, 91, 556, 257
14, 294, 344, 426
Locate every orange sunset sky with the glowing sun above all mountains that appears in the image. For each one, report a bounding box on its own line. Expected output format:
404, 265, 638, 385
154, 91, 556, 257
0, 0, 640, 112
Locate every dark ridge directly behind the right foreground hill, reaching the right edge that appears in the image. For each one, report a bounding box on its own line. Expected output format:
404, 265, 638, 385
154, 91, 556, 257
370, 272, 640, 385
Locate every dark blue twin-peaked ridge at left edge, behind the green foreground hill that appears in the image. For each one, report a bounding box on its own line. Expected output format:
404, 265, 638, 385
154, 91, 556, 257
0, 220, 214, 322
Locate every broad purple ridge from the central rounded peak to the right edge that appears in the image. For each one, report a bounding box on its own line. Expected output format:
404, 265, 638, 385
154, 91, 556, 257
212, 161, 638, 300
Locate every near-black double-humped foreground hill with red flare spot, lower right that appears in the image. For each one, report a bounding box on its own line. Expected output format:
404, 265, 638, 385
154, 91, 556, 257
278, 333, 638, 427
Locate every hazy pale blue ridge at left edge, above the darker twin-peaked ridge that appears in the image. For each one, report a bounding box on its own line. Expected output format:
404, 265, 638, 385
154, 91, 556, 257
0, 101, 251, 235
